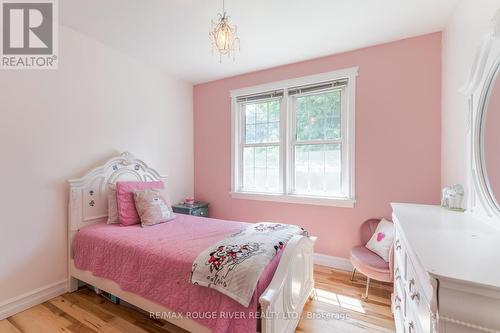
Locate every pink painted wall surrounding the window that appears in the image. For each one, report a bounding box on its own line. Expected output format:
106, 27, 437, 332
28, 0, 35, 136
194, 33, 441, 257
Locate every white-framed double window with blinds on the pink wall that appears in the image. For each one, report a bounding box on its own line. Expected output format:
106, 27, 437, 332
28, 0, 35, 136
231, 68, 357, 207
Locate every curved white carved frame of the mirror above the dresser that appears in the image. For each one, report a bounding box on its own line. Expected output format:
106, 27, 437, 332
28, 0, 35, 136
461, 10, 500, 219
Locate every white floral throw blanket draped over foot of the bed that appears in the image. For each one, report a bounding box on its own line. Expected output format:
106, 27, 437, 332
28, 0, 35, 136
191, 223, 307, 306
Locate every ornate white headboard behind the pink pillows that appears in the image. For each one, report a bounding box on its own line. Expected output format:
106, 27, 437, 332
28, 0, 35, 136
68, 153, 165, 232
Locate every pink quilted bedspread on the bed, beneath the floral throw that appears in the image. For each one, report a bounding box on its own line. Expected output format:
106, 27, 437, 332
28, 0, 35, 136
73, 214, 281, 333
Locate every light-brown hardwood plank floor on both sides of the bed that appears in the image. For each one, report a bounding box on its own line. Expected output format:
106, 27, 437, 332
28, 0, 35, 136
0, 266, 394, 333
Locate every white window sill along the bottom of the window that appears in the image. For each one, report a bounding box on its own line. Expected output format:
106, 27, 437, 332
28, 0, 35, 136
230, 192, 356, 208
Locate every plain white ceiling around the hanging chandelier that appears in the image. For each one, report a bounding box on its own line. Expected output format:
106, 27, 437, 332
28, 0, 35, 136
59, 0, 459, 83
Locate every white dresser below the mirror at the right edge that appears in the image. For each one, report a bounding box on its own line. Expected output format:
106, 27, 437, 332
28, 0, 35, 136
392, 203, 500, 333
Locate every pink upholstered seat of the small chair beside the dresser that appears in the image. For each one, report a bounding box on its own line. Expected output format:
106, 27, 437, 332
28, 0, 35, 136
351, 245, 392, 281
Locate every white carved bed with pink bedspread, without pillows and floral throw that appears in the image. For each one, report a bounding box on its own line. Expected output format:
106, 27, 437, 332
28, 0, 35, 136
68, 153, 316, 333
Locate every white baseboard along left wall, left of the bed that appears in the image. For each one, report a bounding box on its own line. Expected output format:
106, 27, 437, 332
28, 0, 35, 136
0, 280, 68, 320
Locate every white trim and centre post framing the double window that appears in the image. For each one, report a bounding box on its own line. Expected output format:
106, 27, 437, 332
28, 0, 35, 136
230, 67, 358, 208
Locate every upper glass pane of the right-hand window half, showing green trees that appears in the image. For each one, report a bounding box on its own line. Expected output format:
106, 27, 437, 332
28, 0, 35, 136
295, 90, 341, 141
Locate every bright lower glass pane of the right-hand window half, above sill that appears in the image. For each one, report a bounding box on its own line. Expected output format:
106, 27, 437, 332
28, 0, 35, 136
295, 144, 342, 196
